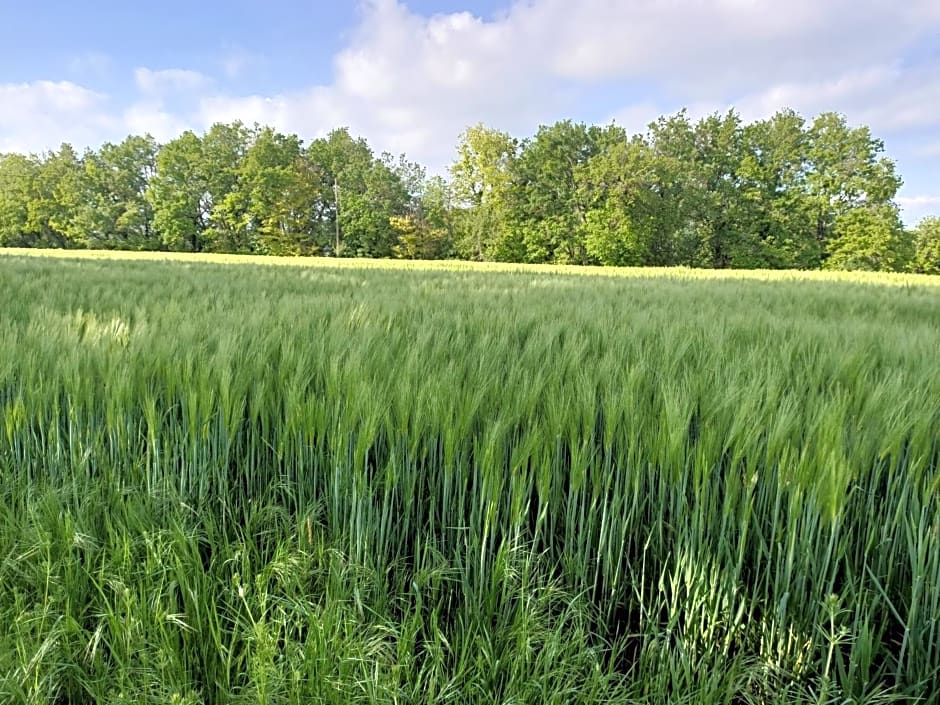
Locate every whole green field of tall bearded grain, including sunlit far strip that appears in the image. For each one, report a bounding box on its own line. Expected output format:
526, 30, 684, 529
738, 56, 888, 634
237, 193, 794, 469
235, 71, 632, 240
0, 251, 940, 705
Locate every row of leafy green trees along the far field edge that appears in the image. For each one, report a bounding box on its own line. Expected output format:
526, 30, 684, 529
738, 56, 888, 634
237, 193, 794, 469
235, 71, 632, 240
0, 110, 940, 273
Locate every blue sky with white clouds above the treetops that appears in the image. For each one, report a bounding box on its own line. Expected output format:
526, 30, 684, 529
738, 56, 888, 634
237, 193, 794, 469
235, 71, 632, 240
0, 0, 940, 224
